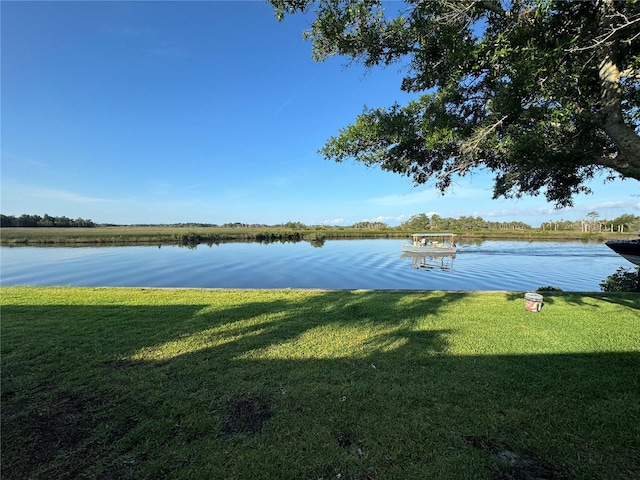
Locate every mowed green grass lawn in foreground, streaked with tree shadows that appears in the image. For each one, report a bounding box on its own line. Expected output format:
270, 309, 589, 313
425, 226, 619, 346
0, 287, 640, 480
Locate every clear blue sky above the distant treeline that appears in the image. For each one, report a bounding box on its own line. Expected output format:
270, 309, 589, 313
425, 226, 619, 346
0, 1, 640, 227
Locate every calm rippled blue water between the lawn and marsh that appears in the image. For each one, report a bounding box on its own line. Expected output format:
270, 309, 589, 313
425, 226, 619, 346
0, 239, 634, 291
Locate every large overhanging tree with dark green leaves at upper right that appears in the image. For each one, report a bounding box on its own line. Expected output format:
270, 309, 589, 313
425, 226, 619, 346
270, 0, 640, 207
